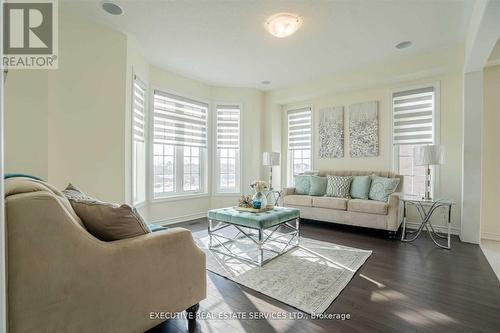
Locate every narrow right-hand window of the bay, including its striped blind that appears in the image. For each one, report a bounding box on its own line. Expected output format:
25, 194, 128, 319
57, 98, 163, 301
215, 105, 241, 193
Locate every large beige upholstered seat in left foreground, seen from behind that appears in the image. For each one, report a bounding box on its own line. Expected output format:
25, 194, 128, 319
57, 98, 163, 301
5, 178, 206, 333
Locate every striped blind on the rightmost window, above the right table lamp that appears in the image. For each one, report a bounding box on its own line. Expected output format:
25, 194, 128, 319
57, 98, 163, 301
392, 87, 435, 145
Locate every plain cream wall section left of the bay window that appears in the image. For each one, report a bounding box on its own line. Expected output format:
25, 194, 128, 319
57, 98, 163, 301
48, 13, 127, 202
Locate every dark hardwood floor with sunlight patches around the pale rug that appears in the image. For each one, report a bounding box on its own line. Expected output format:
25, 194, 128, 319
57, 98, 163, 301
148, 219, 500, 333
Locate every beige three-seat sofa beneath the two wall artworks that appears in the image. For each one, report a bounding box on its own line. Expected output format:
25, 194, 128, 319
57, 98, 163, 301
282, 171, 403, 238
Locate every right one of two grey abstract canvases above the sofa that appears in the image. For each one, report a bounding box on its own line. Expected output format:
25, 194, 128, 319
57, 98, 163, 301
349, 101, 379, 157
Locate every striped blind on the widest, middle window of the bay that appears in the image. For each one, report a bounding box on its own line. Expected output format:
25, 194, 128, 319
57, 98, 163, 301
153, 90, 208, 148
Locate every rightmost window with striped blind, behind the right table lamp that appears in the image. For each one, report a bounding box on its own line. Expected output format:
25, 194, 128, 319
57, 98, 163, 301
392, 86, 436, 195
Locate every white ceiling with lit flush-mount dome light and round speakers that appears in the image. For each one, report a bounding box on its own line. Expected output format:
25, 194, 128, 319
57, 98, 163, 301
62, 0, 473, 89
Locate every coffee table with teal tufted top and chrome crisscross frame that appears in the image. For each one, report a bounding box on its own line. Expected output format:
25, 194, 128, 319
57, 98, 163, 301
207, 207, 300, 266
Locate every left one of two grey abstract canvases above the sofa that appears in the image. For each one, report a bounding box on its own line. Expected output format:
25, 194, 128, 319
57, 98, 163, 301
319, 106, 344, 158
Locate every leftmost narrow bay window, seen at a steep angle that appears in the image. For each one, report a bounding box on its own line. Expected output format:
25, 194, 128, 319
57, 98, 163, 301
132, 75, 147, 205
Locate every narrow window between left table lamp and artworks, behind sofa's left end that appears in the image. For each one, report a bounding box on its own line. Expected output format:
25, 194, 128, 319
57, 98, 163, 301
287, 107, 312, 185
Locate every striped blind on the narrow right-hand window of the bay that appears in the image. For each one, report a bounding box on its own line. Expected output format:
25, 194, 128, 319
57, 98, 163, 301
217, 105, 241, 149
